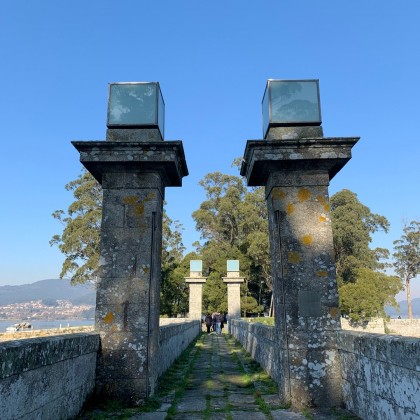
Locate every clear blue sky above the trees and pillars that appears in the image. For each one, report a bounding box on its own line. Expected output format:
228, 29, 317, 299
0, 0, 420, 297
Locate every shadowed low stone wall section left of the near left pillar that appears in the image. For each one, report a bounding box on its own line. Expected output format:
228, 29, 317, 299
0, 333, 99, 420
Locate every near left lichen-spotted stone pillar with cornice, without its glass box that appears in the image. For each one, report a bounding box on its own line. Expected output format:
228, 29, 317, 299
72, 129, 188, 406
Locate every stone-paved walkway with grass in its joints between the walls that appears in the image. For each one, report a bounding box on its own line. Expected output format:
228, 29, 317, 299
79, 333, 357, 420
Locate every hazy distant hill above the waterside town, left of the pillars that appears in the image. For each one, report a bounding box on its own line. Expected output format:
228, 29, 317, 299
0, 279, 96, 306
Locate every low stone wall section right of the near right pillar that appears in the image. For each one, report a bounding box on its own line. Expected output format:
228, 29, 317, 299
338, 331, 420, 420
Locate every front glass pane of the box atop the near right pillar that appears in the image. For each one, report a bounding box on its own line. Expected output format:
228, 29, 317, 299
269, 80, 321, 123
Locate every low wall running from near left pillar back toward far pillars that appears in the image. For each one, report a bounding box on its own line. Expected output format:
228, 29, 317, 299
157, 318, 201, 377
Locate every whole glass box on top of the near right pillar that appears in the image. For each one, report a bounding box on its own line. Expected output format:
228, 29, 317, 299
262, 79, 322, 137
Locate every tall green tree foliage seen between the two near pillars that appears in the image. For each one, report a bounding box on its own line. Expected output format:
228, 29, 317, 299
193, 166, 272, 312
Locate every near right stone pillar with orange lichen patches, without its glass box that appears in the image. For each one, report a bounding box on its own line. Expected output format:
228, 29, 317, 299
241, 127, 358, 407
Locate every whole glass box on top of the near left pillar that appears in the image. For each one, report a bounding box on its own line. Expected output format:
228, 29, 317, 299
107, 82, 165, 138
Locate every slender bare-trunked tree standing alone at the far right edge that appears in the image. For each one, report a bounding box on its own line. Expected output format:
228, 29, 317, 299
393, 220, 420, 319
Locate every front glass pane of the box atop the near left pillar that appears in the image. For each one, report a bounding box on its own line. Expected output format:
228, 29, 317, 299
108, 83, 157, 126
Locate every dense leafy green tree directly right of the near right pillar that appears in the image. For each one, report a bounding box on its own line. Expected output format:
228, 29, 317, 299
330, 190, 402, 320
